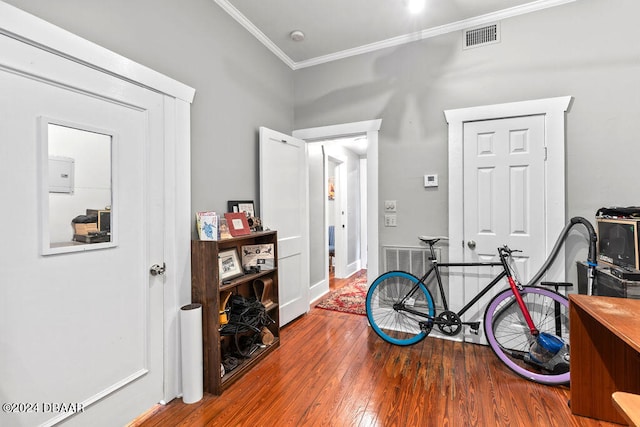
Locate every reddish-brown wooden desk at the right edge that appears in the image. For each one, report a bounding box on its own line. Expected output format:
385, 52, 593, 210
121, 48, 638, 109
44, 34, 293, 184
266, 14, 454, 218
569, 295, 640, 424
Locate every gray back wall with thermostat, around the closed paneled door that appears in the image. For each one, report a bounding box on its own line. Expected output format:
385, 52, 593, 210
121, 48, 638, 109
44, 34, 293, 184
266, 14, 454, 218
294, 0, 640, 282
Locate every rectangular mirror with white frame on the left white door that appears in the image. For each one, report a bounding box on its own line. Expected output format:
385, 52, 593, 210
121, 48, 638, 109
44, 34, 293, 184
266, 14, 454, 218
39, 117, 117, 255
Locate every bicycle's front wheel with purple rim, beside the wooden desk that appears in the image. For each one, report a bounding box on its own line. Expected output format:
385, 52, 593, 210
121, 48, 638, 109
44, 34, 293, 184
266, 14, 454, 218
484, 286, 569, 385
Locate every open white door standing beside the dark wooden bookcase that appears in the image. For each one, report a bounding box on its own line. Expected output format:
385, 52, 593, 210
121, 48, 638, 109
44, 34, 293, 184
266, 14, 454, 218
260, 127, 310, 325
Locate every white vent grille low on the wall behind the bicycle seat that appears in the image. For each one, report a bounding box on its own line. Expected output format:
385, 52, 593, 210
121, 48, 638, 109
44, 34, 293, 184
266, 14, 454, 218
382, 246, 449, 308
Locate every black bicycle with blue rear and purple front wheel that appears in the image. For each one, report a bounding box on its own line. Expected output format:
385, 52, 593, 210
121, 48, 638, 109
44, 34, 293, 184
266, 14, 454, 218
365, 236, 570, 385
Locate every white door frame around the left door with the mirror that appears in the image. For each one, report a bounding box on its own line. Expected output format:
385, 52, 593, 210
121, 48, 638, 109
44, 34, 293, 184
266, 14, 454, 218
0, 1, 195, 402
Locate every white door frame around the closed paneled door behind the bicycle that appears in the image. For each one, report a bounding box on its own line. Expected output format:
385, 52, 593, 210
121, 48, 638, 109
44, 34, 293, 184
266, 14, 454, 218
444, 96, 572, 298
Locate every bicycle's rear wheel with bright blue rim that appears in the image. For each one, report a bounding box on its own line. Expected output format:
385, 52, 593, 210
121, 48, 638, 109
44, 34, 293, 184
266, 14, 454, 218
365, 271, 435, 345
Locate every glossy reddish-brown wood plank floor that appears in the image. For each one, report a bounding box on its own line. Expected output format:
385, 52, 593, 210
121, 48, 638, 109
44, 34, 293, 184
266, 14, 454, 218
130, 276, 618, 427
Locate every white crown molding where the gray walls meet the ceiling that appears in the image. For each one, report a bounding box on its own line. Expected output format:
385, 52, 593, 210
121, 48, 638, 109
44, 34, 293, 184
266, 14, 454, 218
214, 0, 578, 70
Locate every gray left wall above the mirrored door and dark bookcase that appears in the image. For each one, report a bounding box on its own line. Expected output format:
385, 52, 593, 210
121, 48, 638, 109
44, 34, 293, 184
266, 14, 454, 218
7, 0, 293, 227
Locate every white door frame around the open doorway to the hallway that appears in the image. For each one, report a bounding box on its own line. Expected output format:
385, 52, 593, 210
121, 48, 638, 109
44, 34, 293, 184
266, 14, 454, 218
293, 119, 382, 283
